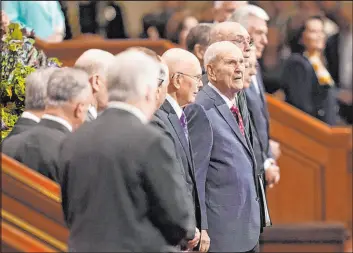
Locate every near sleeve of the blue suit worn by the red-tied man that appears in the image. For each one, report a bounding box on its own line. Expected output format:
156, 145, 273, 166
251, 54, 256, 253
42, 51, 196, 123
185, 104, 213, 230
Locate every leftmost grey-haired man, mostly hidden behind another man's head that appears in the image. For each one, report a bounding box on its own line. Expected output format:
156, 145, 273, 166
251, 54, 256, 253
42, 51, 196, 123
6, 68, 56, 139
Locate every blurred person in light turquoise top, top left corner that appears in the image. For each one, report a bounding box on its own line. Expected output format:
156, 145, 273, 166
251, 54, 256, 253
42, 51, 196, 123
2, 1, 65, 42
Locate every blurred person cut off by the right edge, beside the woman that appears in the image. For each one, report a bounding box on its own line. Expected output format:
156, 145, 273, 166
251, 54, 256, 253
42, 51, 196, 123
325, 1, 353, 124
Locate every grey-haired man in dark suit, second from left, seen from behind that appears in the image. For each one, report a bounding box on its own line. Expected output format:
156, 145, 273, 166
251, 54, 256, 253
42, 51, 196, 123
2, 68, 92, 182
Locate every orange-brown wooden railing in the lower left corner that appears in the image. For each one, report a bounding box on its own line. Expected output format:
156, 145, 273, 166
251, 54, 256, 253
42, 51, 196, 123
1, 154, 68, 252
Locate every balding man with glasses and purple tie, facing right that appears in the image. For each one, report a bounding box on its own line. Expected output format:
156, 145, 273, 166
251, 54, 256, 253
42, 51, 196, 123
155, 48, 202, 250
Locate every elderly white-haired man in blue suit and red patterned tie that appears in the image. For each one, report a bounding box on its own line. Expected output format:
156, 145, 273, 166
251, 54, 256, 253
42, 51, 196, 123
185, 41, 261, 252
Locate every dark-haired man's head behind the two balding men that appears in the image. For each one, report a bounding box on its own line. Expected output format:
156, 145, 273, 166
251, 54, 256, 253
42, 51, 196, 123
186, 23, 212, 75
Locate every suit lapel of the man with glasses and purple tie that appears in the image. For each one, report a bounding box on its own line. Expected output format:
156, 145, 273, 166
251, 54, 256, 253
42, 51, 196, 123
161, 100, 194, 174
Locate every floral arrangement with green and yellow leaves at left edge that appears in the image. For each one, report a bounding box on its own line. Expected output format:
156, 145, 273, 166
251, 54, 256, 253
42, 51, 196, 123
0, 17, 62, 139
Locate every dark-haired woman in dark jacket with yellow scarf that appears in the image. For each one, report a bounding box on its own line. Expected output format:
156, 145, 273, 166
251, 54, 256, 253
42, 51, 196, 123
281, 11, 338, 125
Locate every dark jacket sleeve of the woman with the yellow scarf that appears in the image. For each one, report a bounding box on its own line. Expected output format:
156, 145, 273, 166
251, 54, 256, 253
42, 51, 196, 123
281, 56, 316, 116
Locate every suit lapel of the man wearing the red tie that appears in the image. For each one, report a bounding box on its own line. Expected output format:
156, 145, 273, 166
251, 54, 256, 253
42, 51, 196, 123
204, 85, 252, 155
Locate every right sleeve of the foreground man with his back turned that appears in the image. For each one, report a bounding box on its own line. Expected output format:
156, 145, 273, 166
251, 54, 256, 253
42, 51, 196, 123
142, 133, 196, 245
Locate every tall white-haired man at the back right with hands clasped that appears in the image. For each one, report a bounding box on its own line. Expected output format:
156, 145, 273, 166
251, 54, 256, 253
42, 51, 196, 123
229, 4, 280, 188
